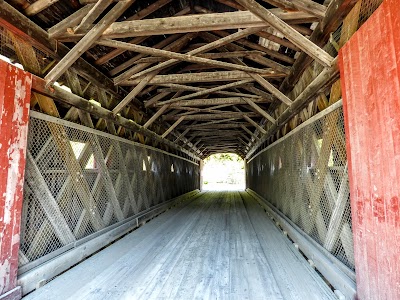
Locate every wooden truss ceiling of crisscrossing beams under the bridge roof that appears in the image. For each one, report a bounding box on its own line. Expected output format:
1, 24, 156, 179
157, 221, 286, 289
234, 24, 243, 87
0, 0, 356, 157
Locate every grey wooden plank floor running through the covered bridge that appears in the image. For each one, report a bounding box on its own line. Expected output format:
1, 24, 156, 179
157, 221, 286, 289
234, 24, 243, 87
24, 192, 336, 300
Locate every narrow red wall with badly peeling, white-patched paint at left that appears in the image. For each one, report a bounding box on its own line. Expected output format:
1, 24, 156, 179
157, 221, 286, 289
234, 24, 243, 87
0, 61, 32, 298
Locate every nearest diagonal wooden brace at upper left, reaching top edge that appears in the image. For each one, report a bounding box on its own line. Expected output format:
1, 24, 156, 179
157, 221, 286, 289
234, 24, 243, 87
45, 0, 135, 84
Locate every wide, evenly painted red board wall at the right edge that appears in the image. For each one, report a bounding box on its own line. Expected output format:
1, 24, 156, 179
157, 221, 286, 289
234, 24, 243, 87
339, 0, 400, 300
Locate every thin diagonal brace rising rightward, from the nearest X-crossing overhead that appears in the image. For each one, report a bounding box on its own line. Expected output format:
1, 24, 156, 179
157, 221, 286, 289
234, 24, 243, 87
118, 28, 264, 82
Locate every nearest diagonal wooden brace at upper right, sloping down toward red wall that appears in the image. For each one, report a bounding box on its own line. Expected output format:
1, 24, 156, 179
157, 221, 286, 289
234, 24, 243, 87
237, 0, 333, 67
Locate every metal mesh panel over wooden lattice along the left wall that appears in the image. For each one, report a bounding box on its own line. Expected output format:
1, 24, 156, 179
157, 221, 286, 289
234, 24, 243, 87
19, 112, 199, 266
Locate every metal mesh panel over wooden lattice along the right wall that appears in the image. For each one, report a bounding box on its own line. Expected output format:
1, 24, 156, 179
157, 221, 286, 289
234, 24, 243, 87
246, 105, 354, 269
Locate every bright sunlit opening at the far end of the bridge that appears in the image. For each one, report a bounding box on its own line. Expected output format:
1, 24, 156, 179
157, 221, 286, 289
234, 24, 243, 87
201, 153, 246, 191
